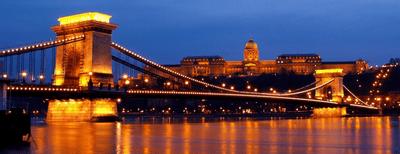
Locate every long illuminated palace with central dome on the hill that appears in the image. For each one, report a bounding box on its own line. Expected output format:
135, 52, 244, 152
159, 38, 368, 77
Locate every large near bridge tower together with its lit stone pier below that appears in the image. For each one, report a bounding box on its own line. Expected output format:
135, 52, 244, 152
46, 12, 118, 121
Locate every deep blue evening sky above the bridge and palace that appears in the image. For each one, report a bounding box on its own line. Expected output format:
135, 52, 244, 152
0, 0, 400, 66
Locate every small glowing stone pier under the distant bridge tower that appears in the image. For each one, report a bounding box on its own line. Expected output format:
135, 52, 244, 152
312, 107, 347, 118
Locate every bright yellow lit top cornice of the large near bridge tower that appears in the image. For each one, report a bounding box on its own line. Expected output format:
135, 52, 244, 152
58, 12, 112, 25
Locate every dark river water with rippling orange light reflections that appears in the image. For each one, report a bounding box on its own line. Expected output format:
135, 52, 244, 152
0, 116, 400, 154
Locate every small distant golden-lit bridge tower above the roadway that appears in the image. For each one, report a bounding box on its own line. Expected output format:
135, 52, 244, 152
314, 69, 345, 103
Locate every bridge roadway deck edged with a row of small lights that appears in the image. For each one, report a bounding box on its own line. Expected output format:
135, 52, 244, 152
7, 85, 378, 111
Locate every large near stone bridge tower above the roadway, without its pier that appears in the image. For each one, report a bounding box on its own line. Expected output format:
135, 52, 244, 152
51, 12, 118, 86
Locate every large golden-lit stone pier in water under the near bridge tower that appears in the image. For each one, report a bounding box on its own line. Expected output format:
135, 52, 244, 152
46, 99, 119, 122
